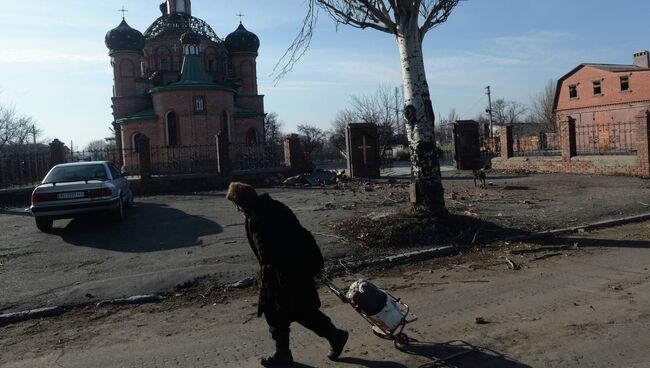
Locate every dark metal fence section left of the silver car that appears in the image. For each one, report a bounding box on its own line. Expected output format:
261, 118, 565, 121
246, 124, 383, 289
0, 150, 50, 188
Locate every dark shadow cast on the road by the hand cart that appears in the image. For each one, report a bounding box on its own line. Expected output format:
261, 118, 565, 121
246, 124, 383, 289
402, 339, 530, 368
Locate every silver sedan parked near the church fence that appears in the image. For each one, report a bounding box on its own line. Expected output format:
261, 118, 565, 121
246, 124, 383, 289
30, 161, 133, 231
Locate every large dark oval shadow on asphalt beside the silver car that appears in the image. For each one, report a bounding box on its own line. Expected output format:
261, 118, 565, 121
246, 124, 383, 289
50, 203, 223, 253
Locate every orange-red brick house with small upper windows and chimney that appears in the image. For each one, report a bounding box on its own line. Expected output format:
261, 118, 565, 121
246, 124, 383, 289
554, 51, 650, 126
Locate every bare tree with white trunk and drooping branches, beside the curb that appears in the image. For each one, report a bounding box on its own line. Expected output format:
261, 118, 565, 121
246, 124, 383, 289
275, 0, 460, 215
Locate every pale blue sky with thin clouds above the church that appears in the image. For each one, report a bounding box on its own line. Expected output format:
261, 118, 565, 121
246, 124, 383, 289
0, 0, 650, 147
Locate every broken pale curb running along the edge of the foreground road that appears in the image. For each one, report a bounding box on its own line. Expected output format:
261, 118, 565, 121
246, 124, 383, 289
0, 213, 650, 327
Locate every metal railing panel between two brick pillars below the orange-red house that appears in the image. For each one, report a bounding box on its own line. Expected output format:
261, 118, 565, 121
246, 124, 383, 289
576, 121, 638, 155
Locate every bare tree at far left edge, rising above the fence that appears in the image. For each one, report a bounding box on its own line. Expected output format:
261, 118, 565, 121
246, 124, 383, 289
0, 105, 41, 151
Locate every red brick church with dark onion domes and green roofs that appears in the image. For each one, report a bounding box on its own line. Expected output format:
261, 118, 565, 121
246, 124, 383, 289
105, 0, 265, 172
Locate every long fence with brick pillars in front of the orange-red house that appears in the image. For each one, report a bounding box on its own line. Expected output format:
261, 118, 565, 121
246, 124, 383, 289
492, 115, 650, 176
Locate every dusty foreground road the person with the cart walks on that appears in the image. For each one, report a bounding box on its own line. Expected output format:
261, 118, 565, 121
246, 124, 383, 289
0, 222, 650, 368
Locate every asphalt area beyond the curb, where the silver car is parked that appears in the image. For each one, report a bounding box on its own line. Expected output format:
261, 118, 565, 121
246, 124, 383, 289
0, 172, 650, 313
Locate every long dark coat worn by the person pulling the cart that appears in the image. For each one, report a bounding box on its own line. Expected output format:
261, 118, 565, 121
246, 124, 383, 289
246, 194, 322, 316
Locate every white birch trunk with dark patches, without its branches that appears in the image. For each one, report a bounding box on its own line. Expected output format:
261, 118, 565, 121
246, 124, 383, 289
395, 9, 446, 215
